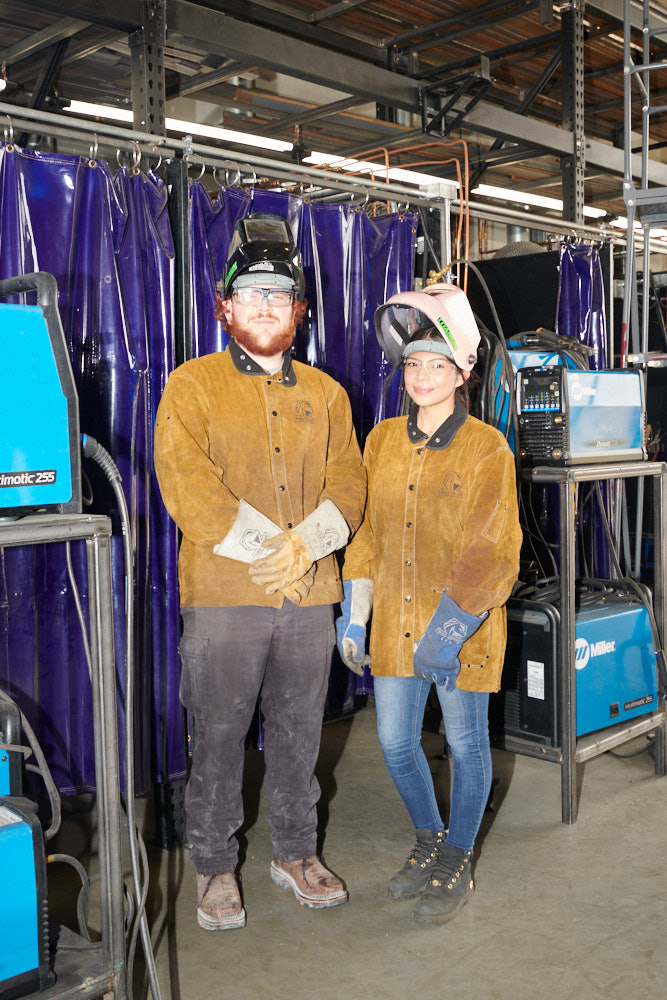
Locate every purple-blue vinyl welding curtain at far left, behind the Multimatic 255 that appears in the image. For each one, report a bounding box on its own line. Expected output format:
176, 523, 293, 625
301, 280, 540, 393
0, 144, 185, 792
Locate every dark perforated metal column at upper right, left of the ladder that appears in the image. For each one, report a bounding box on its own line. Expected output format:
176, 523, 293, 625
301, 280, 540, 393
561, 0, 586, 223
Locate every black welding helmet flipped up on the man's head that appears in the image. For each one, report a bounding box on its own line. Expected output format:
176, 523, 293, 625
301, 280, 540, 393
222, 212, 306, 300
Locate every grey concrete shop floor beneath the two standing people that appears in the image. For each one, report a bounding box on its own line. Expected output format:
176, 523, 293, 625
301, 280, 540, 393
124, 703, 667, 1000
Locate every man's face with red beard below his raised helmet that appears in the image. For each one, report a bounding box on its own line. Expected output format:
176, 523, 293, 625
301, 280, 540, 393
220, 277, 300, 358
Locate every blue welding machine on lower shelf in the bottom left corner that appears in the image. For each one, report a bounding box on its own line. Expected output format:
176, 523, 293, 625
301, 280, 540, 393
0, 797, 50, 1000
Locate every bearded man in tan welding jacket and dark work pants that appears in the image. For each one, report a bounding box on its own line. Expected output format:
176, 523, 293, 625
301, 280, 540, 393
155, 214, 366, 930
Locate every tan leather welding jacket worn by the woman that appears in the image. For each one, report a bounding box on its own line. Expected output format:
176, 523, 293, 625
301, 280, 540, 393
343, 403, 521, 691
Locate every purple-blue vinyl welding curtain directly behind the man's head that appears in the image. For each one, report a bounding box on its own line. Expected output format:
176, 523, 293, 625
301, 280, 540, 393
190, 182, 417, 717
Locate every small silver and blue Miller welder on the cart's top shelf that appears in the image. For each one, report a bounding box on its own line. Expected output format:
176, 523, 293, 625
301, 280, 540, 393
516, 366, 647, 466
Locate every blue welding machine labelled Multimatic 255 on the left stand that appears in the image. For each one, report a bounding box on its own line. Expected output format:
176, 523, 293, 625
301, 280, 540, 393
0, 272, 81, 516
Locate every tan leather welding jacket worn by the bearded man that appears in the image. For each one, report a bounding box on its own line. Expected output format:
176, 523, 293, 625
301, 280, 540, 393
155, 340, 366, 607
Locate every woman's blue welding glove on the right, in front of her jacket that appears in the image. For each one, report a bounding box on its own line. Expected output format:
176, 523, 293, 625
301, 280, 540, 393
413, 592, 489, 690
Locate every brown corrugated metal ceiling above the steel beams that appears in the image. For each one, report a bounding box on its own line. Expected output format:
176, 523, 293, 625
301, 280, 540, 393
0, 0, 667, 223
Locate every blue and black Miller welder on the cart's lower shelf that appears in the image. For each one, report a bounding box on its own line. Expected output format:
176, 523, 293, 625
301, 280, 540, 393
489, 580, 658, 747
